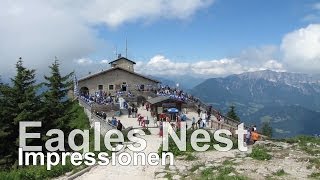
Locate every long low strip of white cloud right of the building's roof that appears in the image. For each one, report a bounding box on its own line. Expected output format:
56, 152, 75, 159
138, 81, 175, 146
135, 55, 285, 77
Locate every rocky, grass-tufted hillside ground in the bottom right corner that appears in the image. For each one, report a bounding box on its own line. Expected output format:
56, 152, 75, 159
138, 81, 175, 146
155, 137, 320, 180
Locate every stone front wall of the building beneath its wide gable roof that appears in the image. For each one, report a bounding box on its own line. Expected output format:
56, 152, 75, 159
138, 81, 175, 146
79, 69, 158, 94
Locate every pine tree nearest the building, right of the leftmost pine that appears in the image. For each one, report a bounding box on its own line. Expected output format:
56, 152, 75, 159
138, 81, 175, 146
42, 59, 73, 143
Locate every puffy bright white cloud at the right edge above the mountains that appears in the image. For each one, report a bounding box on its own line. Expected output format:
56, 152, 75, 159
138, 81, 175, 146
281, 24, 320, 73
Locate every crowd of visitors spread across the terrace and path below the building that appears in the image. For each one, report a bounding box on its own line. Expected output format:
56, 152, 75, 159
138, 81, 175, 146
80, 83, 258, 143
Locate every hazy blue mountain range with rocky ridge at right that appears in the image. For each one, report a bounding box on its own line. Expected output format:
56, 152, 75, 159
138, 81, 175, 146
190, 70, 320, 137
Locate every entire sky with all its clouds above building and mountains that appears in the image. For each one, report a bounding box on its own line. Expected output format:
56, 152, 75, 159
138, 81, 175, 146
0, 0, 320, 77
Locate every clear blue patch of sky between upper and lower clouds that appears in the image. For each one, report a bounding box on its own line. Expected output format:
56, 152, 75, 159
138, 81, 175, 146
94, 0, 313, 60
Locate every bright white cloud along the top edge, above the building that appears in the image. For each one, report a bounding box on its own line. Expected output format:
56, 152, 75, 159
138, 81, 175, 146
75, 0, 213, 27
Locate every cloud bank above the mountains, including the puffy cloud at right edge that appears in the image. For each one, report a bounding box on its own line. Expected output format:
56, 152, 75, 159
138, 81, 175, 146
138, 24, 320, 77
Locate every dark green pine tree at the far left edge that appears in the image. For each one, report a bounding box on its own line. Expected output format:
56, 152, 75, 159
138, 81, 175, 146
1, 58, 41, 167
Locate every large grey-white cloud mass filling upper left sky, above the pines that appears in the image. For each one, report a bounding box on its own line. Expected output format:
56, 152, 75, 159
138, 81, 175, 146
0, 0, 213, 79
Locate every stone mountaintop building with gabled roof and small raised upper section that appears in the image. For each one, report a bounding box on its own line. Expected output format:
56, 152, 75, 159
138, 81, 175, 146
78, 57, 160, 94
